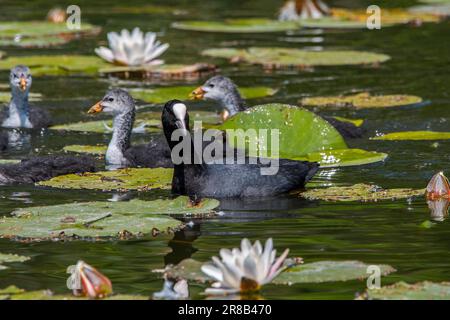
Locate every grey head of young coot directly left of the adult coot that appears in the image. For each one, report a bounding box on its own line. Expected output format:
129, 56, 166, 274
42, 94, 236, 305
88, 89, 135, 115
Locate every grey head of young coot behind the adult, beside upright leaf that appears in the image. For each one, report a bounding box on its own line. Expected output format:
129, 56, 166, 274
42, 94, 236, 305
190, 75, 237, 100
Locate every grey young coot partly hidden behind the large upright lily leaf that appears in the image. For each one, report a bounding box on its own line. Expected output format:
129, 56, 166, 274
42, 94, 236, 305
190, 75, 364, 139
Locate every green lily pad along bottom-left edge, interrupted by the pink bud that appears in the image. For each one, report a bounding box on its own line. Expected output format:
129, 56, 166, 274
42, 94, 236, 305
0, 286, 149, 300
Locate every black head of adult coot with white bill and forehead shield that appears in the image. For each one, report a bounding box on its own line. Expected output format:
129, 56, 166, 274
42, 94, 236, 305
161, 100, 189, 145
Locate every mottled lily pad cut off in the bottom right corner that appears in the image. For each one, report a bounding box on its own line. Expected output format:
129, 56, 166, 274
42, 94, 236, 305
360, 281, 450, 300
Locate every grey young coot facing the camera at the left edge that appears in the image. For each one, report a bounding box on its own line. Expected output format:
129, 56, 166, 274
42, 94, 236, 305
0, 65, 51, 129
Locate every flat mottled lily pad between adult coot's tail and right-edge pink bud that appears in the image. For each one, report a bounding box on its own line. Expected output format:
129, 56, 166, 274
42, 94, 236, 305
300, 183, 425, 202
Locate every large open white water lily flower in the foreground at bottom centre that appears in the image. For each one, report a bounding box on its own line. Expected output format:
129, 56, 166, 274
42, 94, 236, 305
202, 238, 289, 295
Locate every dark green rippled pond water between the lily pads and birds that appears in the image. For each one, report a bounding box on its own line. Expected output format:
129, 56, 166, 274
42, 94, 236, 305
0, 0, 450, 299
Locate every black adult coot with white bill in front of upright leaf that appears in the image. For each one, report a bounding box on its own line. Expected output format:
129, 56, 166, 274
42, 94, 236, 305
161, 100, 319, 198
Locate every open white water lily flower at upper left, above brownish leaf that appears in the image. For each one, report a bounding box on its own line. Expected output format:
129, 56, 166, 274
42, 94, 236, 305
95, 28, 169, 66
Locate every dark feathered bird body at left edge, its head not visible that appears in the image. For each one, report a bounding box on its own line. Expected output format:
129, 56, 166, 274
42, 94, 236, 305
0, 155, 95, 185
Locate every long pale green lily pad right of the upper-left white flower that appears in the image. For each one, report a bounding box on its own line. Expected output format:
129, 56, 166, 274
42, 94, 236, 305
202, 47, 390, 68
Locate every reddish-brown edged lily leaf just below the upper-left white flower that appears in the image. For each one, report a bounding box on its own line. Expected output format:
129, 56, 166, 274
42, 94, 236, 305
98, 63, 217, 79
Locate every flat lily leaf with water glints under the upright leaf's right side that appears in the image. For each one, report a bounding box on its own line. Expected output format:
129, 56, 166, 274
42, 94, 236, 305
291, 149, 388, 168
